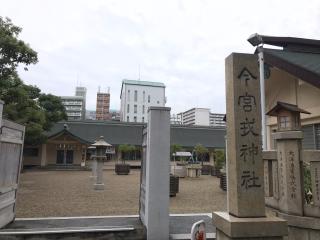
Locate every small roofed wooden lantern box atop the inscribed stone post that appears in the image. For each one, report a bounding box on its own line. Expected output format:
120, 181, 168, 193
267, 102, 310, 132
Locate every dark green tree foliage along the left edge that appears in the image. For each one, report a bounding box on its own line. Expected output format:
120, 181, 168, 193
0, 17, 66, 145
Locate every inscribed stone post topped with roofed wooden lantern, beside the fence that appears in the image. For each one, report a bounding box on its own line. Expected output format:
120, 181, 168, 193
267, 102, 310, 216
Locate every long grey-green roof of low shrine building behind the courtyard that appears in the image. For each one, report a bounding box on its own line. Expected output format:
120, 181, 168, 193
47, 121, 226, 148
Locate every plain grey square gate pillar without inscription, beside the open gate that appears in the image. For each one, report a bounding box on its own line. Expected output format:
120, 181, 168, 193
145, 107, 170, 240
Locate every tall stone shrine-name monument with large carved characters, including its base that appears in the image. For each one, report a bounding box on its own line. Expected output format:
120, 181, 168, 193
213, 53, 287, 240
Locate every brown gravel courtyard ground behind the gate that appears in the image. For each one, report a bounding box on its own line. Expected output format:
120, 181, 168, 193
17, 170, 227, 217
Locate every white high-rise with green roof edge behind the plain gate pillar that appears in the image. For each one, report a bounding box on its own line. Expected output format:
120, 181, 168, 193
120, 79, 166, 122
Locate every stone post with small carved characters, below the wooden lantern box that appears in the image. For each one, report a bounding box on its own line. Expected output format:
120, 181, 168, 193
273, 131, 303, 216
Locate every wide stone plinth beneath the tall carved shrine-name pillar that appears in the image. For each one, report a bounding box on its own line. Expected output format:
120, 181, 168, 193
212, 212, 288, 240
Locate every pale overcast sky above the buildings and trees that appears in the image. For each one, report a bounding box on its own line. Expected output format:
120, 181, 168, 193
0, 0, 320, 113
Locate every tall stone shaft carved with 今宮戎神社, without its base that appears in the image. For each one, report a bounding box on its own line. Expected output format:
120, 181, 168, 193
226, 54, 265, 217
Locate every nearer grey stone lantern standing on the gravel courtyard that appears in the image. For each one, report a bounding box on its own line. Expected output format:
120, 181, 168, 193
91, 136, 112, 190
